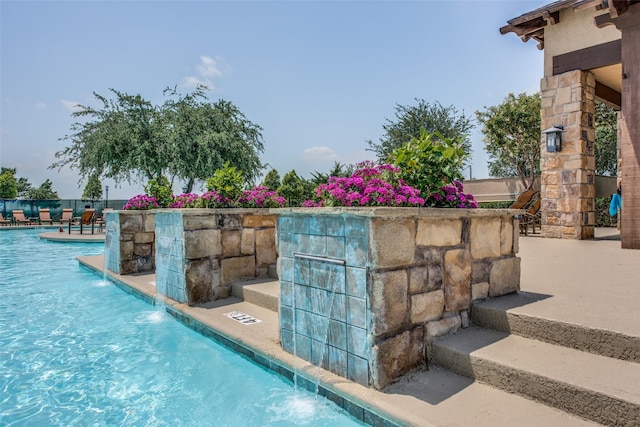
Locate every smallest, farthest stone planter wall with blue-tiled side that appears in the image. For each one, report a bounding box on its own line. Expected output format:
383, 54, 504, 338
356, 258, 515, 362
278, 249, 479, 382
105, 210, 155, 274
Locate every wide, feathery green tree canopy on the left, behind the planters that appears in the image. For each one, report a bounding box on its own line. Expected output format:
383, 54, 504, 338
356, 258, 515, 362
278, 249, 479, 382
51, 86, 263, 191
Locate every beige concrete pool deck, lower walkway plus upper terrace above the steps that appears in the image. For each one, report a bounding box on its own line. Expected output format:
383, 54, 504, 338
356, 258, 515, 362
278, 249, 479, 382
79, 229, 640, 426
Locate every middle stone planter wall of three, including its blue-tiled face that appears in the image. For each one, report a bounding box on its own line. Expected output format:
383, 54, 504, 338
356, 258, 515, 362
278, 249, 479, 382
155, 209, 277, 305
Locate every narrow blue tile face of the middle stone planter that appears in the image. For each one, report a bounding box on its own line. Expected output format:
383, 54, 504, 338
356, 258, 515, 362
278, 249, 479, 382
155, 211, 187, 303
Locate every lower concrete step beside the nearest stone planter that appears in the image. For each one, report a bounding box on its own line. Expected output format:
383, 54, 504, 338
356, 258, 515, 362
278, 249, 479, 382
431, 327, 640, 426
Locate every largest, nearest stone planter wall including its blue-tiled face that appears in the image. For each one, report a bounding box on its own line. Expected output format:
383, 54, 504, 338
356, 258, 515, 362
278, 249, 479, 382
274, 208, 520, 388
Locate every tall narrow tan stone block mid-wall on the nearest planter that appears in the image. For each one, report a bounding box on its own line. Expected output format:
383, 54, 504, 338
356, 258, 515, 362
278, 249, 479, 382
444, 249, 471, 311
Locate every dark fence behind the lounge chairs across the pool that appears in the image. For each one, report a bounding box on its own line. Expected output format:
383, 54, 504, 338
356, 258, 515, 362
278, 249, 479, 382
0, 199, 127, 221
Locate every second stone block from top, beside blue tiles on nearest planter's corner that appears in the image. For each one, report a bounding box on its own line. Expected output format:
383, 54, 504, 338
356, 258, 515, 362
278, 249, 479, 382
370, 270, 408, 336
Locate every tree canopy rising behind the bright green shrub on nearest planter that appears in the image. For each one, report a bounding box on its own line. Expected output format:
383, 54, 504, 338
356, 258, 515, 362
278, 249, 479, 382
368, 98, 473, 162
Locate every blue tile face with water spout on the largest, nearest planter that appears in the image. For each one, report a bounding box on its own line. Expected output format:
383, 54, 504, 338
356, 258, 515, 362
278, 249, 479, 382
278, 214, 370, 385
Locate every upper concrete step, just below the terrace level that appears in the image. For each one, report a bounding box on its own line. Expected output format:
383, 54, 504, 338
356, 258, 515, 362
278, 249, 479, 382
471, 292, 640, 363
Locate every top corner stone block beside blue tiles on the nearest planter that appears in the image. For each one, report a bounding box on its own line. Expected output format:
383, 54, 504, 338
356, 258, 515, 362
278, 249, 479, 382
371, 218, 416, 268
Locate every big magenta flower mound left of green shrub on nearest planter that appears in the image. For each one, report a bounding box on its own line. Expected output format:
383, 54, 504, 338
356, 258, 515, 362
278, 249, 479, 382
302, 162, 424, 207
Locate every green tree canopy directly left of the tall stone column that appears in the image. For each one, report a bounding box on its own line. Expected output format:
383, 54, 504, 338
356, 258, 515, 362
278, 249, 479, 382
476, 93, 541, 189
